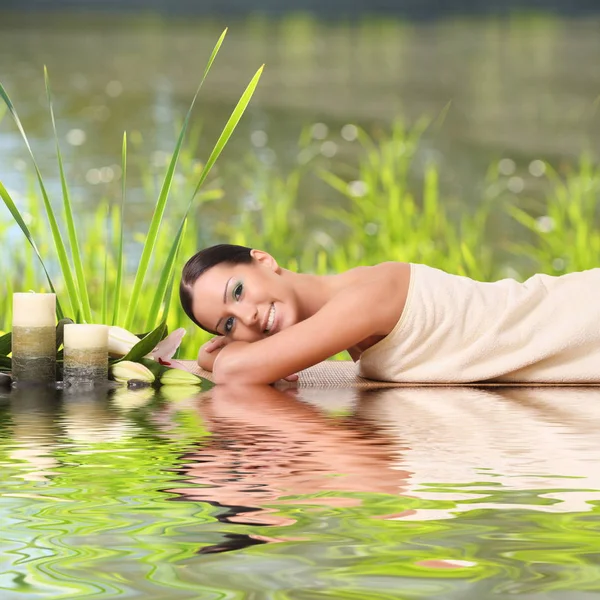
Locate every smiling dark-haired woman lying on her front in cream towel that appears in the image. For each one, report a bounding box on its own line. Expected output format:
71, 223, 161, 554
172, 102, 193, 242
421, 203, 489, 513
180, 244, 600, 383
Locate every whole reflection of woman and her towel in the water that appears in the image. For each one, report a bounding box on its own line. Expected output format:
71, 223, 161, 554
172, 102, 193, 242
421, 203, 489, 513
161, 386, 600, 525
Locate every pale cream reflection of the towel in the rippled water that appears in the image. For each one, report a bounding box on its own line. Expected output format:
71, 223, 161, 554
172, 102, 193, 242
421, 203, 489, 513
357, 387, 600, 518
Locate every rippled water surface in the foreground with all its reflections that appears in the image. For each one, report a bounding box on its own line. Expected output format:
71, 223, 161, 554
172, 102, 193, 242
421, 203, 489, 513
0, 386, 600, 599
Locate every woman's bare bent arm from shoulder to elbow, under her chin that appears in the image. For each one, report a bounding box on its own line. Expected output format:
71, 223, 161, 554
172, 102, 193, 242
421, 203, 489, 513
213, 263, 409, 383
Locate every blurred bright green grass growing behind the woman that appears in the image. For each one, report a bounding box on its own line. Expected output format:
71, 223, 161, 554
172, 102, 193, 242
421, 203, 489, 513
0, 98, 600, 357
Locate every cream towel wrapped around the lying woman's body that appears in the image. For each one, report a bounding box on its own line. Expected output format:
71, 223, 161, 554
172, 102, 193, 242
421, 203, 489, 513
359, 264, 600, 383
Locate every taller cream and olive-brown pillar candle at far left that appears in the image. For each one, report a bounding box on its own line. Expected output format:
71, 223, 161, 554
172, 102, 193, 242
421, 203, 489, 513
12, 293, 56, 383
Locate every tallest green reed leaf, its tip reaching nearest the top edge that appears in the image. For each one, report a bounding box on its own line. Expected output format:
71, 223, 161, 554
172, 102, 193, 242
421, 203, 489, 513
124, 29, 227, 329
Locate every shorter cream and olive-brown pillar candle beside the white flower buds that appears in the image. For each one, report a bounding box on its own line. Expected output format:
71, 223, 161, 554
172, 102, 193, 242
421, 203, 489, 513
63, 323, 108, 385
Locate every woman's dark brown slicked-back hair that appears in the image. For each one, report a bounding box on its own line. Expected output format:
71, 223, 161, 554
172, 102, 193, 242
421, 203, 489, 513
179, 244, 252, 333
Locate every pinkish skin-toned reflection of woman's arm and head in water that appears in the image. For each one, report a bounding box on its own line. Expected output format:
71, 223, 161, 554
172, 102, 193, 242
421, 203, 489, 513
166, 386, 407, 523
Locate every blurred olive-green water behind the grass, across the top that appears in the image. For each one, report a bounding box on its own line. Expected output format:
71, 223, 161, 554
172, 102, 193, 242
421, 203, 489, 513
0, 0, 600, 234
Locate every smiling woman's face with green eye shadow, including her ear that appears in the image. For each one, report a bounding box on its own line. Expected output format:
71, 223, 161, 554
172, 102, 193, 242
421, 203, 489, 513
192, 250, 298, 342
